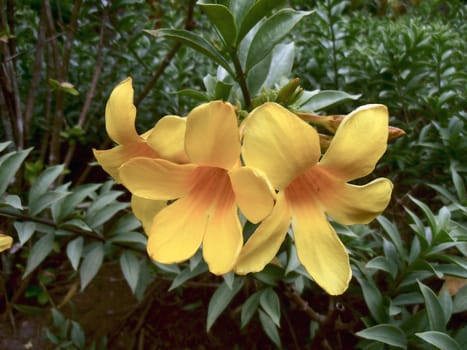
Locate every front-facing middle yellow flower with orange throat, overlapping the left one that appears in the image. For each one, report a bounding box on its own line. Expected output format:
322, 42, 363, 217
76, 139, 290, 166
119, 101, 275, 274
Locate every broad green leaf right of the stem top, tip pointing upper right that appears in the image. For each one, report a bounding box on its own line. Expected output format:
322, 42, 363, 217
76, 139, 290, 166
245, 9, 311, 72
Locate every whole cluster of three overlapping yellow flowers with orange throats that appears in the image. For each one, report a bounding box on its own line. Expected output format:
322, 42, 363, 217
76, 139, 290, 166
94, 78, 392, 295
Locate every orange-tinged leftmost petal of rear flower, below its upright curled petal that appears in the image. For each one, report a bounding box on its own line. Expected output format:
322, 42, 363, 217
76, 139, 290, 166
93, 142, 159, 182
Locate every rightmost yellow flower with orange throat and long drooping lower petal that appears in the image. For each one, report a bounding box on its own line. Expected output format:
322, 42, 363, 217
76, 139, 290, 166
235, 103, 392, 295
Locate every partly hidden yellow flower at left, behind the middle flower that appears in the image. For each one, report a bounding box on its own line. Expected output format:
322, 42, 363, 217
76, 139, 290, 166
93, 78, 187, 232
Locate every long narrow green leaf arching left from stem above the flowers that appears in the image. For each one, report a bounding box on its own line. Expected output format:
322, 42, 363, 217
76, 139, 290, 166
145, 28, 235, 77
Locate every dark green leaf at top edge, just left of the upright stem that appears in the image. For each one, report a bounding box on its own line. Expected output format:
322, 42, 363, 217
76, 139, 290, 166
199, 4, 237, 48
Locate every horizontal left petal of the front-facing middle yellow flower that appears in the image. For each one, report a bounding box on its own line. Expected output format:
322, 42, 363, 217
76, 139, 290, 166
119, 157, 197, 200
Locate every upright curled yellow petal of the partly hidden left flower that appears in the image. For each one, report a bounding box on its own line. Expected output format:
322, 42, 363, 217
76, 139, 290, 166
105, 78, 141, 145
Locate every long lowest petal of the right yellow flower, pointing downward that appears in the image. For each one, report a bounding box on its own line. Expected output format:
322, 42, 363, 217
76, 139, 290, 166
290, 200, 352, 295
